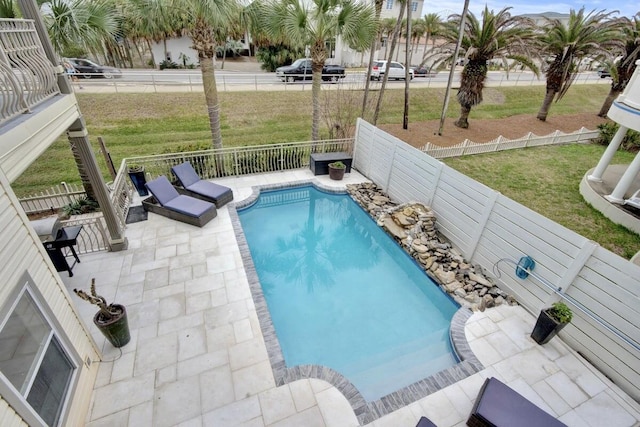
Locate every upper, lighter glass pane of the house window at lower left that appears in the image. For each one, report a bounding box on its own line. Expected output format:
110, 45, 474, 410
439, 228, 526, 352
0, 292, 51, 395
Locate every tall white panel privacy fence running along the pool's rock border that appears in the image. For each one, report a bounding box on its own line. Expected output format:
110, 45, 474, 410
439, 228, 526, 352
354, 120, 640, 400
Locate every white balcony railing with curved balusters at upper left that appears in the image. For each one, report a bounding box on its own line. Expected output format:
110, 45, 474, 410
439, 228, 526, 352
0, 19, 60, 125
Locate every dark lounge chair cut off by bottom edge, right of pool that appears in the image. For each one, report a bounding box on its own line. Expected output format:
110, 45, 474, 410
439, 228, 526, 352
467, 378, 567, 427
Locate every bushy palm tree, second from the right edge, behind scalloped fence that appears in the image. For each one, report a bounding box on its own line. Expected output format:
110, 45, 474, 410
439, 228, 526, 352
537, 7, 624, 121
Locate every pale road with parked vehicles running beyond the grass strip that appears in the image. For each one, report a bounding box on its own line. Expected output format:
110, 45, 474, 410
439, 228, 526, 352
70, 70, 611, 92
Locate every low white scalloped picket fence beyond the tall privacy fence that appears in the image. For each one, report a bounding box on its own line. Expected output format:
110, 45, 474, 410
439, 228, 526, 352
420, 127, 600, 159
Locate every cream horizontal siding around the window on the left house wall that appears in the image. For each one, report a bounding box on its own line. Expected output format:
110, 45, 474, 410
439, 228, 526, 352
0, 170, 101, 427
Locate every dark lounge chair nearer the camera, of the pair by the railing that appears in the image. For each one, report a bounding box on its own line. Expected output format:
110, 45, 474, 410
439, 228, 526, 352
142, 175, 218, 227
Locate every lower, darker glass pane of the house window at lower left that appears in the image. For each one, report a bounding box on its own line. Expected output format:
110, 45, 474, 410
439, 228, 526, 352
27, 336, 73, 426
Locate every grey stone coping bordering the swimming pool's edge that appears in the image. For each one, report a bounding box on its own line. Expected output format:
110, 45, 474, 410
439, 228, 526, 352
227, 180, 484, 425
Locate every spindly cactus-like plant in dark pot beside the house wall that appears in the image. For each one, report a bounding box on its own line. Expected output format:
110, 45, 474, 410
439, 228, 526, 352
73, 278, 131, 347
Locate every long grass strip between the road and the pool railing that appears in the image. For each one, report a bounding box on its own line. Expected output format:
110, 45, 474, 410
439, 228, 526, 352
13, 85, 608, 196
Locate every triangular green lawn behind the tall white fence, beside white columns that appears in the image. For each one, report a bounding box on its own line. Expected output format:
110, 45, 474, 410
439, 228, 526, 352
444, 144, 640, 259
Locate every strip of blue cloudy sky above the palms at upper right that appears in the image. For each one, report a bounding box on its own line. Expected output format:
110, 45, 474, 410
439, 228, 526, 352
422, 0, 640, 18
